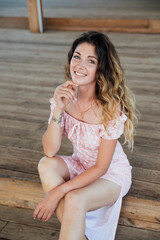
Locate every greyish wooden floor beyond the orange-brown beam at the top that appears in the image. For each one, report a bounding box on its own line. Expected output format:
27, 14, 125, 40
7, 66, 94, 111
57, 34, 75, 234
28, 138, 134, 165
0, 0, 160, 19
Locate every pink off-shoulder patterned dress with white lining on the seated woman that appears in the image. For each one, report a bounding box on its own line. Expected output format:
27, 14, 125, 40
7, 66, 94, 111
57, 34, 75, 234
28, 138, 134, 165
48, 98, 132, 240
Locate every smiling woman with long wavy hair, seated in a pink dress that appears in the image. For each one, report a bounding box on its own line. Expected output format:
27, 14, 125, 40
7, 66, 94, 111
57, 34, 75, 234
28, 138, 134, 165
34, 32, 137, 240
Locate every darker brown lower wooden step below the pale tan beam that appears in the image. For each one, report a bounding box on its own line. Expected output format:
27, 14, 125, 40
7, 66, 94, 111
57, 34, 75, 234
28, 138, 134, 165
0, 205, 160, 240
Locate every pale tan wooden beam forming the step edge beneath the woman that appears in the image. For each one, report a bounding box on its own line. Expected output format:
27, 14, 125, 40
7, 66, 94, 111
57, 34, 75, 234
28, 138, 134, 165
0, 178, 160, 231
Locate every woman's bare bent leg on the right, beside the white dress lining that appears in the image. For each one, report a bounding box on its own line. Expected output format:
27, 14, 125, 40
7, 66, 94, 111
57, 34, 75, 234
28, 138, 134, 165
59, 178, 121, 240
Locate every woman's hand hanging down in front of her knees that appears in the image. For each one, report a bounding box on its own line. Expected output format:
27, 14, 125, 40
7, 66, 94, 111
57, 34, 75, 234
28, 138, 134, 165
33, 187, 63, 221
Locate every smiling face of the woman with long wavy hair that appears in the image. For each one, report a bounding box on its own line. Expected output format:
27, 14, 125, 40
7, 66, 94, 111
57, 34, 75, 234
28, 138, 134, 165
70, 42, 98, 85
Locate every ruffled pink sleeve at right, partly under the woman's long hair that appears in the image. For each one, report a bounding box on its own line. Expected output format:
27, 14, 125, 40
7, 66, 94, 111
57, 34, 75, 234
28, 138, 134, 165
100, 112, 127, 139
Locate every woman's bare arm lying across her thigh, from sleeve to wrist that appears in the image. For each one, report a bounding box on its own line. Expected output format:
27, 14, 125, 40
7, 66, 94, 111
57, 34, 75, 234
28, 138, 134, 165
59, 139, 117, 196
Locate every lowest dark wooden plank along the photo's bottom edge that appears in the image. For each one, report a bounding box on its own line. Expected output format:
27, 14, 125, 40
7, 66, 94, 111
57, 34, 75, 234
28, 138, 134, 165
0, 220, 160, 240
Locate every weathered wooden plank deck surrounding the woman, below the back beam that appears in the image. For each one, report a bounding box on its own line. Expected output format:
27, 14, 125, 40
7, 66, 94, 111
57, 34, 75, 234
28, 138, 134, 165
0, 29, 160, 240
